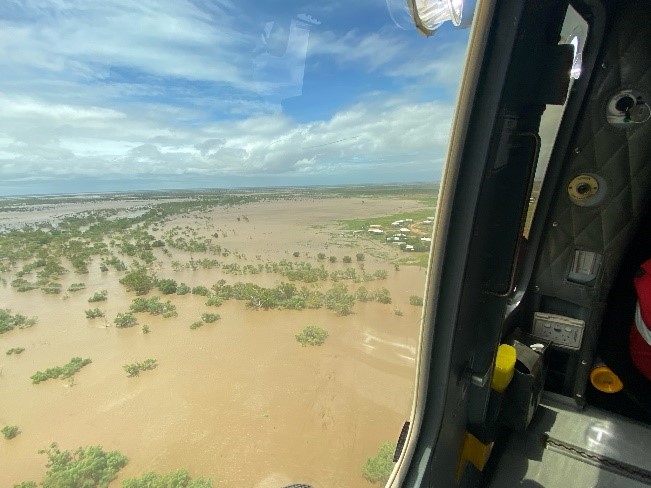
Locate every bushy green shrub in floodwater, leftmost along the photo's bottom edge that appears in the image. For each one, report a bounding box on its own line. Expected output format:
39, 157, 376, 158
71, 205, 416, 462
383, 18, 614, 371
39, 443, 129, 488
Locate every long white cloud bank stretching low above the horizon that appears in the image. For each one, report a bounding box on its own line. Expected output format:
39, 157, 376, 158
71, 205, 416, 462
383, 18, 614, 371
0, 90, 452, 179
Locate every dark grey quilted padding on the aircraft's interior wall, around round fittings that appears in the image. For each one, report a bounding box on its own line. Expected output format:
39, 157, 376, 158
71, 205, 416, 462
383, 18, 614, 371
534, 4, 651, 308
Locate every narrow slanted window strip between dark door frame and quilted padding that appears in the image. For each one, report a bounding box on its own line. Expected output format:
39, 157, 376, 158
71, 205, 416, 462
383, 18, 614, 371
524, 6, 588, 237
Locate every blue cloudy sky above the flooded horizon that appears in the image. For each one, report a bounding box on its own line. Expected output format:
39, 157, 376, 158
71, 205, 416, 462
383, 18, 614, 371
0, 0, 468, 195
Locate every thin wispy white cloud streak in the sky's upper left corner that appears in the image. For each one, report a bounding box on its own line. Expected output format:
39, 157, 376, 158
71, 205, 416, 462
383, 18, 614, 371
0, 0, 253, 86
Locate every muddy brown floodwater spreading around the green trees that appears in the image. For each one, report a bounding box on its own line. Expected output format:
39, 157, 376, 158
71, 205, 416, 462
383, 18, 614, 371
0, 199, 425, 488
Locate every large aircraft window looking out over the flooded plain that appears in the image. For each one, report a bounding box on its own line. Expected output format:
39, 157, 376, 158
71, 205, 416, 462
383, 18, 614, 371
0, 0, 468, 488
